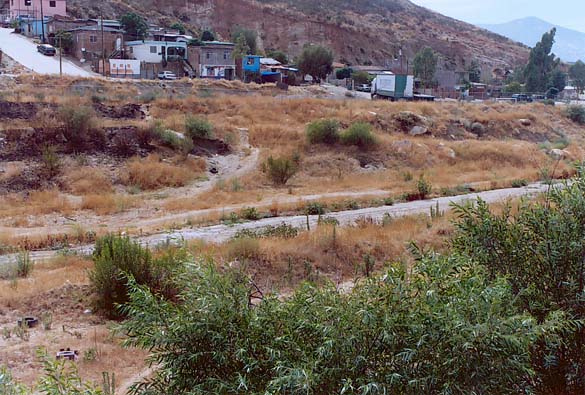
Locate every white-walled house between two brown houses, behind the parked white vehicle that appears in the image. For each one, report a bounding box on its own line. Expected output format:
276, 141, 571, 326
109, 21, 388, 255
126, 41, 187, 63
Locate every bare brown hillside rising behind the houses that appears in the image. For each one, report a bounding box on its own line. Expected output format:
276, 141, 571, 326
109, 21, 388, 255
60, 0, 527, 69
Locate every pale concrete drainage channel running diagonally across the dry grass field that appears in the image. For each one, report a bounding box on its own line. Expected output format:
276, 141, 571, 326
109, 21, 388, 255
0, 183, 550, 265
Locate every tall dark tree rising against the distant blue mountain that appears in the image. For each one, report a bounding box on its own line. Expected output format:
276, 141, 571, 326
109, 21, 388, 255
524, 28, 560, 92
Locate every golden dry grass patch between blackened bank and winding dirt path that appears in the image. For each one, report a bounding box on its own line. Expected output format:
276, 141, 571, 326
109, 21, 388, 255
121, 155, 200, 190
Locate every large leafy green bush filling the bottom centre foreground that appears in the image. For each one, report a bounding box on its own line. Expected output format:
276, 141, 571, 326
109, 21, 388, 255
121, 257, 555, 395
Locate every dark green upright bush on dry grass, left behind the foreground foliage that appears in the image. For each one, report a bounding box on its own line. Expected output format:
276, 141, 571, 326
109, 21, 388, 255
89, 235, 184, 317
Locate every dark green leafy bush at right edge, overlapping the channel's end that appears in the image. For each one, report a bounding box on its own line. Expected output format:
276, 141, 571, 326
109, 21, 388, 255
452, 177, 585, 394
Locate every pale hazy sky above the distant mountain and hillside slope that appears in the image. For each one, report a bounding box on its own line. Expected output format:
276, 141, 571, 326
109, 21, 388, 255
411, 0, 585, 31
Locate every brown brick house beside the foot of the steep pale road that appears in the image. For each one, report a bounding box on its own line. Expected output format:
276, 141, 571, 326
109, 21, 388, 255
68, 25, 124, 61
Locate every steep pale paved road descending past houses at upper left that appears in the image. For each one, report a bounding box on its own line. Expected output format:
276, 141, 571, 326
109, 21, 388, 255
0, 28, 94, 77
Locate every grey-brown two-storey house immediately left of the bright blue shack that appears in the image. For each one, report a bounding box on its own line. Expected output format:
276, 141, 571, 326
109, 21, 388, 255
188, 41, 236, 80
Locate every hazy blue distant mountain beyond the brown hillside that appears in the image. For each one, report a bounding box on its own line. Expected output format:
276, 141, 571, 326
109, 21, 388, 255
479, 17, 585, 62
